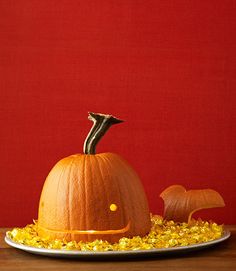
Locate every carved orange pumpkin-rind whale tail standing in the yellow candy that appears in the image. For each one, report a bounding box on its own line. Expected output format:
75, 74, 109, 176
160, 185, 225, 222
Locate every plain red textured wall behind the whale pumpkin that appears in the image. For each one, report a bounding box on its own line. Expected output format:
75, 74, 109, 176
0, 0, 236, 226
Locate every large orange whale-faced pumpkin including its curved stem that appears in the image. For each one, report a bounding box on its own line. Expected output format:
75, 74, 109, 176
38, 113, 151, 242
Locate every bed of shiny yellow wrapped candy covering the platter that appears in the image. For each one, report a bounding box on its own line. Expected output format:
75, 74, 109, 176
7, 215, 223, 251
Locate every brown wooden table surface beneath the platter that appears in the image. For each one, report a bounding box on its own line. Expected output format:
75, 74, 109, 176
0, 225, 236, 271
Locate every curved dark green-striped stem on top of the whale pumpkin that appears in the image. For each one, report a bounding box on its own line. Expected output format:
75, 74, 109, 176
84, 112, 123, 154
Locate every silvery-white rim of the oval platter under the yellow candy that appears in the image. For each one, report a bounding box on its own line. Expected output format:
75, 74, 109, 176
5, 230, 230, 258
